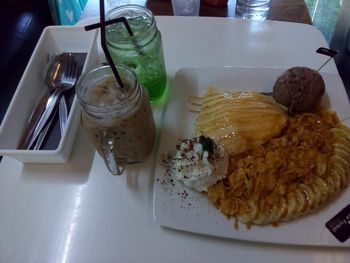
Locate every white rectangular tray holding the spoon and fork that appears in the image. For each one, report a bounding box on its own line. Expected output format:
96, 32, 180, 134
0, 26, 97, 163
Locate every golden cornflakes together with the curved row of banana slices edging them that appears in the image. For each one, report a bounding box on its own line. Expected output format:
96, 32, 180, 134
193, 88, 350, 226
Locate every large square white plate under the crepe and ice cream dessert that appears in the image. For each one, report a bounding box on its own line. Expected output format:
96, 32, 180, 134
154, 67, 350, 247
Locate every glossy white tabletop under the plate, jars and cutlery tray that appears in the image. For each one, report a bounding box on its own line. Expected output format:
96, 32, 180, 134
0, 17, 350, 263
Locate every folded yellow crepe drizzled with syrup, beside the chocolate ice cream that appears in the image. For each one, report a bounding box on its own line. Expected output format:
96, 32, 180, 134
195, 87, 287, 156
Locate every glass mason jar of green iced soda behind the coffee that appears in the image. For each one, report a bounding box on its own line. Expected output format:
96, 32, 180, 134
106, 5, 166, 102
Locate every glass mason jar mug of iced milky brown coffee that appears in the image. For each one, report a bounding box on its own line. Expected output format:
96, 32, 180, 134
76, 64, 155, 175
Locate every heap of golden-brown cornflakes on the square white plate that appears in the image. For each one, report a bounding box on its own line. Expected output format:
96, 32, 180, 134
208, 109, 339, 227
